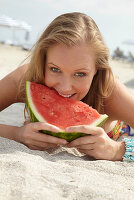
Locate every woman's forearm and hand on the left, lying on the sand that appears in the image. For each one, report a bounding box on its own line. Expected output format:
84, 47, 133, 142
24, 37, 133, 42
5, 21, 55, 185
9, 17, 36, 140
0, 122, 67, 151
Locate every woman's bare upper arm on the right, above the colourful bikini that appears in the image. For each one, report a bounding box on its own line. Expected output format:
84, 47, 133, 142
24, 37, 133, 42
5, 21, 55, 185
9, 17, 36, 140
105, 80, 134, 128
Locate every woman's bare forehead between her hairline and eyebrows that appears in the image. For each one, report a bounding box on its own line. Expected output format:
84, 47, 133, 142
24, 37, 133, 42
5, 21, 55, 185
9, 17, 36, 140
46, 43, 95, 70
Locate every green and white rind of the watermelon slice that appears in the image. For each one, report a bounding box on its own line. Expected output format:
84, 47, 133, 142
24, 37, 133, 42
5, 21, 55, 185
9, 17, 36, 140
26, 81, 108, 142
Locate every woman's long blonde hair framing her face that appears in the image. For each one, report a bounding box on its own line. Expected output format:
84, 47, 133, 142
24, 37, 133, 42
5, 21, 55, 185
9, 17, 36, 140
20, 12, 113, 113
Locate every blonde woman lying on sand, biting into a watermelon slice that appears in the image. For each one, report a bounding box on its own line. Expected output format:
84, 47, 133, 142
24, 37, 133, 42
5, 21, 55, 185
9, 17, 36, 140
0, 12, 134, 161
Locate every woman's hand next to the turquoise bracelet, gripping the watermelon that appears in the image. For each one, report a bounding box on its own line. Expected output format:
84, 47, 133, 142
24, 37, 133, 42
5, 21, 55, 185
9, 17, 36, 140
65, 125, 125, 160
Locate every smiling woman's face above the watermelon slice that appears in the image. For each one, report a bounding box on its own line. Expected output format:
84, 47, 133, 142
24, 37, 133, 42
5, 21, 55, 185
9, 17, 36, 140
45, 43, 96, 100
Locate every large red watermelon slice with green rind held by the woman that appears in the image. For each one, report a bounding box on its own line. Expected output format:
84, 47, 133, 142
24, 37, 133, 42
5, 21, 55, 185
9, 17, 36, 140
26, 81, 108, 142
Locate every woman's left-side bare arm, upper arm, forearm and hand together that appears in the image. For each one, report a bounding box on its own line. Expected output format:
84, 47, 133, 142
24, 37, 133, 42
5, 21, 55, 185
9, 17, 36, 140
0, 65, 67, 150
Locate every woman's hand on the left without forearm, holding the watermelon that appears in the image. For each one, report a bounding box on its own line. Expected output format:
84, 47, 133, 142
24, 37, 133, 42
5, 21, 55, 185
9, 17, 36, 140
16, 122, 67, 151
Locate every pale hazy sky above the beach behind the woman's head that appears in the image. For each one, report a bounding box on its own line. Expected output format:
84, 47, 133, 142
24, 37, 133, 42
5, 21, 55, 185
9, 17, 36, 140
0, 0, 134, 53
